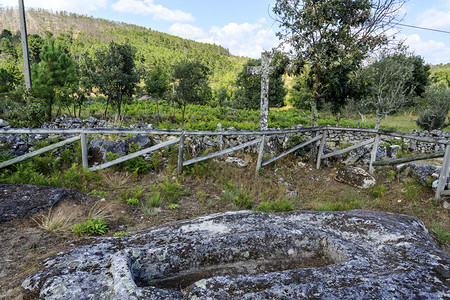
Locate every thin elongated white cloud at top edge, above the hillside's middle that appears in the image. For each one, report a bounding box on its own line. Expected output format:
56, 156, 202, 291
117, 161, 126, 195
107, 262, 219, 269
112, 0, 195, 22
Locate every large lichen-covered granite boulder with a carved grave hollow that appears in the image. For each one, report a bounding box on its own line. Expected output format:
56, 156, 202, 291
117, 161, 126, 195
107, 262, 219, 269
22, 210, 450, 299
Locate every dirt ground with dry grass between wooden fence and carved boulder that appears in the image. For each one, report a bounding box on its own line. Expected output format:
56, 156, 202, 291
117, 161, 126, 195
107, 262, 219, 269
0, 157, 450, 299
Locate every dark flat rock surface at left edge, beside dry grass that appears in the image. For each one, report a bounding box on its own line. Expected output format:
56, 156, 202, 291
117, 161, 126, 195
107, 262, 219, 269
0, 184, 66, 223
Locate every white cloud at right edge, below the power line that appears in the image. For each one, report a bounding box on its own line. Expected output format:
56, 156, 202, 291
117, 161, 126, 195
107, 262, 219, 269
404, 34, 450, 64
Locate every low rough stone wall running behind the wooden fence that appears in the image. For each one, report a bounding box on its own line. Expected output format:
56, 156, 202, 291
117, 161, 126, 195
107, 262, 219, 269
0, 117, 450, 155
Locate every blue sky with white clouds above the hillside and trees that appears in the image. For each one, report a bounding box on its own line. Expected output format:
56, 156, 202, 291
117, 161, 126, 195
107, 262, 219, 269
0, 0, 450, 64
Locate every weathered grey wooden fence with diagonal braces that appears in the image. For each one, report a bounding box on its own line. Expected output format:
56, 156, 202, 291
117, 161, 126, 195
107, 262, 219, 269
0, 126, 450, 200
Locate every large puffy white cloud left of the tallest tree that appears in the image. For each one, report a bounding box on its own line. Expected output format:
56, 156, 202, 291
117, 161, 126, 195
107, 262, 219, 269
169, 19, 278, 58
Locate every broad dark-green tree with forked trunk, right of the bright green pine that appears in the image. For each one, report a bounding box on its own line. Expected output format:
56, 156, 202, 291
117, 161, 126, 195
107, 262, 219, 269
81, 41, 139, 117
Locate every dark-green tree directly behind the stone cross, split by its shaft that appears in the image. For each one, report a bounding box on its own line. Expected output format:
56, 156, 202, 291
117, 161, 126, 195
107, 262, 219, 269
235, 52, 289, 109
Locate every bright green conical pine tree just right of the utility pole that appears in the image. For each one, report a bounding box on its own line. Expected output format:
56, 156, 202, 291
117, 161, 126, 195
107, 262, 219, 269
31, 39, 78, 121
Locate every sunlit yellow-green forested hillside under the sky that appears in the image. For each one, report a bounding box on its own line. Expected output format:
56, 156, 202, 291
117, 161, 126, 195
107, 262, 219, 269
0, 7, 247, 88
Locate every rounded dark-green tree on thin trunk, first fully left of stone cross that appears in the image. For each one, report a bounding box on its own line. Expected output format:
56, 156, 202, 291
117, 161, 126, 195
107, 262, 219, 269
173, 60, 212, 124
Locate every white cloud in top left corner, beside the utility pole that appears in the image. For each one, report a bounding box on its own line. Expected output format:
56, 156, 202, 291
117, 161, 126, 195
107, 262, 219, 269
1, 0, 108, 14
